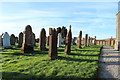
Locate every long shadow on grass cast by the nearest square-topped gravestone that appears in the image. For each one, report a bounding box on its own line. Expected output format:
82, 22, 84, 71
58, 56, 98, 62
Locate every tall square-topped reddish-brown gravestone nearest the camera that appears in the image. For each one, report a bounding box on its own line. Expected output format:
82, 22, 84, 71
48, 28, 58, 60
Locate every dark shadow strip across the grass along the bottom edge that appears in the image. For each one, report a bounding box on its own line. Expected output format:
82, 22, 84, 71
2, 72, 97, 80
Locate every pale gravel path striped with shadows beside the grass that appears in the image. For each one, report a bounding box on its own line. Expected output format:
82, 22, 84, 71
99, 46, 120, 80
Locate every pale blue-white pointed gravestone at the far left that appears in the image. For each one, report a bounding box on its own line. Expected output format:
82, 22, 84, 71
3, 32, 11, 49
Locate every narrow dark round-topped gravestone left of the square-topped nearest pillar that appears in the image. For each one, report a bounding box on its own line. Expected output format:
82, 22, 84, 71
38, 28, 46, 51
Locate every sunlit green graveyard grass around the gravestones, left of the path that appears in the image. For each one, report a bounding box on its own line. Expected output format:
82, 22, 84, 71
0, 45, 101, 80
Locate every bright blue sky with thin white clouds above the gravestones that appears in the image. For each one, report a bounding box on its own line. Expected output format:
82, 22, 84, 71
0, 2, 118, 39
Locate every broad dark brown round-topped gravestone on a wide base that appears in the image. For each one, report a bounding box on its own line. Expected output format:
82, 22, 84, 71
21, 25, 34, 53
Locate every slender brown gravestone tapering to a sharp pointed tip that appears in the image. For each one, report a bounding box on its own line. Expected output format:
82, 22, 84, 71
65, 25, 72, 55
